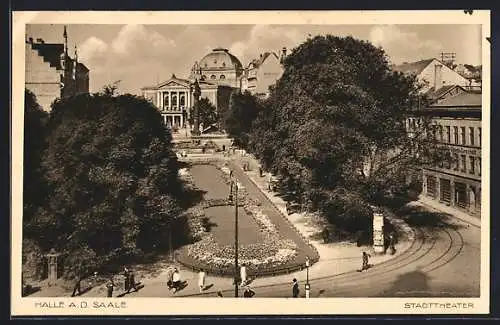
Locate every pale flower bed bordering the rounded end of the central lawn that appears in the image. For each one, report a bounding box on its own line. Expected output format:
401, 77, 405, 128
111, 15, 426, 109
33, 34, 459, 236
178, 163, 298, 274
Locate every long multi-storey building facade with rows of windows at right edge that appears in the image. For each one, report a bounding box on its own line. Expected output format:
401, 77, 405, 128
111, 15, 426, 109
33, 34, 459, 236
407, 91, 482, 216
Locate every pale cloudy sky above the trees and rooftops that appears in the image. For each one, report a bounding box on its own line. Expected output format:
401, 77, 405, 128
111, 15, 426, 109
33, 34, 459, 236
26, 24, 481, 95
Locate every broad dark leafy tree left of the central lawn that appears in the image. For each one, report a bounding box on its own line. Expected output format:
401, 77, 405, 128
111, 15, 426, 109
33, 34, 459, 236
30, 93, 182, 274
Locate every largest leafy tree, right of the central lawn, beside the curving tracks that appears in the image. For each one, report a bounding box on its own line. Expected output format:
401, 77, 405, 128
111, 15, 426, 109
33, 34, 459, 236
250, 35, 443, 230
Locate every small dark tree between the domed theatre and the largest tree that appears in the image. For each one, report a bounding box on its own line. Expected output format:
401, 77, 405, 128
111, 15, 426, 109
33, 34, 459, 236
224, 90, 262, 147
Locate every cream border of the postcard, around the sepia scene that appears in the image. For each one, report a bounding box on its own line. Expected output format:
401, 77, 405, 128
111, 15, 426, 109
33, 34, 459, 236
11, 10, 491, 316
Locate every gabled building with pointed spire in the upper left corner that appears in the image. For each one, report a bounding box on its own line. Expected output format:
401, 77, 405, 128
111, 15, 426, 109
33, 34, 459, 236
25, 28, 89, 111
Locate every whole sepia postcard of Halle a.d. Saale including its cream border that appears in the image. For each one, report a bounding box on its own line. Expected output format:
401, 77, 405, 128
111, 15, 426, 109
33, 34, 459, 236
10, 10, 491, 316
